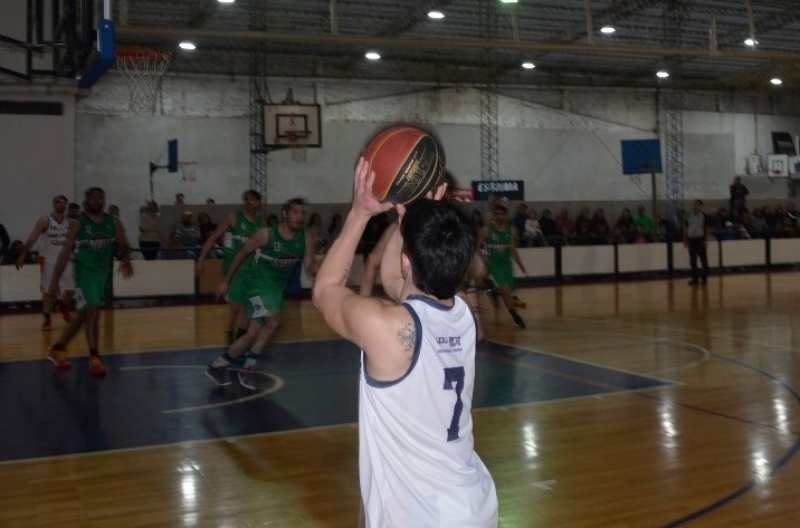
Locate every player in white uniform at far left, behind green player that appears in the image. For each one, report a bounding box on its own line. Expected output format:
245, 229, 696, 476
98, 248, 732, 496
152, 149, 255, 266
17, 194, 75, 331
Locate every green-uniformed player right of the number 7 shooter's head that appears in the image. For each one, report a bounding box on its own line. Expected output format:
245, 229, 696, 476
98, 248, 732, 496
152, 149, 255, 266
478, 204, 527, 328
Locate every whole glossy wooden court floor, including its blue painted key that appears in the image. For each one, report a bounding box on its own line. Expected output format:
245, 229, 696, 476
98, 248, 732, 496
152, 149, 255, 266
0, 272, 800, 528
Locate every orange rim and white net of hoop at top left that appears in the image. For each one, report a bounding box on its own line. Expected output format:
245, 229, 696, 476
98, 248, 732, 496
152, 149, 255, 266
117, 48, 172, 114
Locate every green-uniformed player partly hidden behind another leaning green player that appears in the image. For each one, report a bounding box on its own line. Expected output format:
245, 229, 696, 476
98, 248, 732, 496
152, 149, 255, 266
195, 189, 263, 345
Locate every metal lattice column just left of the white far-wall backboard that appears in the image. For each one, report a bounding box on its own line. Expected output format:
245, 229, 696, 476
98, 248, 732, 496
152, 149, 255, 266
250, 2, 271, 213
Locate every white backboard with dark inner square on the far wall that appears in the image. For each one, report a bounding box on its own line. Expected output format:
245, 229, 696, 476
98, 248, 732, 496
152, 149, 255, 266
264, 104, 322, 148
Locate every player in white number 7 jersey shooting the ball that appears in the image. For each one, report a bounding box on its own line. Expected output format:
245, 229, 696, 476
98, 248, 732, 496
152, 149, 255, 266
313, 158, 498, 528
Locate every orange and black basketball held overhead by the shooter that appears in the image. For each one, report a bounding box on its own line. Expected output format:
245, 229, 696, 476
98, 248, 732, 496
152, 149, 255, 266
364, 126, 444, 204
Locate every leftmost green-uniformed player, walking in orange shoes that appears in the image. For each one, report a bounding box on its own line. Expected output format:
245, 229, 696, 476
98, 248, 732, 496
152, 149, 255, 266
47, 187, 133, 376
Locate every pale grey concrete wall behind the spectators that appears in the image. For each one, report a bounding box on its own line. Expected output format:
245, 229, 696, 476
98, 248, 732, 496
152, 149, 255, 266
0, 71, 800, 240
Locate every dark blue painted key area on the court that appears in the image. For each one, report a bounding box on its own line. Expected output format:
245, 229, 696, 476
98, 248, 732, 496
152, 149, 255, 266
0, 341, 667, 460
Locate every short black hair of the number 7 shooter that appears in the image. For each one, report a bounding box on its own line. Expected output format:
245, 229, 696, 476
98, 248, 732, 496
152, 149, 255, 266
400, 199, 475, 299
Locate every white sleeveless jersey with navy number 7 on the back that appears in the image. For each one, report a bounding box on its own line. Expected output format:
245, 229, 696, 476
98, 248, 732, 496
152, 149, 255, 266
359, 296, 497, 528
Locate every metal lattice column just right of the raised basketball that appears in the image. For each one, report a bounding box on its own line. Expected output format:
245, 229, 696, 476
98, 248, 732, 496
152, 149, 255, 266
480, 0, 500, 180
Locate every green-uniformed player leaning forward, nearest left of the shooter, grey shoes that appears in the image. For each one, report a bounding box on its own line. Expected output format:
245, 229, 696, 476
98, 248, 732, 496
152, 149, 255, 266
205, 198, 319, 389
